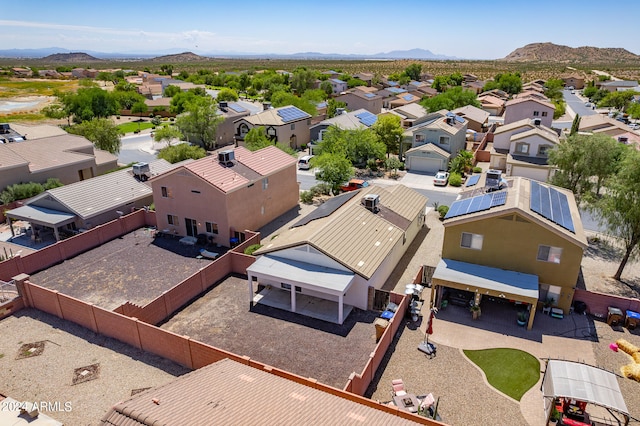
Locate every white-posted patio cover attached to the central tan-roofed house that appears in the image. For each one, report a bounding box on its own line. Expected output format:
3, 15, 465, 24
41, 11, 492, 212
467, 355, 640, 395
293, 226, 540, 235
247, 255, 355, 324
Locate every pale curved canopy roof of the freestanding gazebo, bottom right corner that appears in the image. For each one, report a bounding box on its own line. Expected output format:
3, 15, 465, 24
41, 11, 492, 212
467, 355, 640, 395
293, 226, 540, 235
542, 360, 629, 417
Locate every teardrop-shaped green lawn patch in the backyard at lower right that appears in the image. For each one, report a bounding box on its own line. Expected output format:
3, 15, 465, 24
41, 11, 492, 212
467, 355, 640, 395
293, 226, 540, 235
464, 348, 540, 401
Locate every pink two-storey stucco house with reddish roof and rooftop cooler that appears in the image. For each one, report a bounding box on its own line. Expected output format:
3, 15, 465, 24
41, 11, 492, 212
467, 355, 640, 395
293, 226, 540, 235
149, 146, 299, 247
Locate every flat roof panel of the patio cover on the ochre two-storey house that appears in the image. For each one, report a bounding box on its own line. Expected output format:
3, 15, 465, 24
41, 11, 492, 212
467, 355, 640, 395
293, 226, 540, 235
432, 259, 538, 303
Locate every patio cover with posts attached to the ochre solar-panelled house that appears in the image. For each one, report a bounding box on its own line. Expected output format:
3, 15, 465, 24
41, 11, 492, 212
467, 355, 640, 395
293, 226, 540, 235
431, 259, 539, 330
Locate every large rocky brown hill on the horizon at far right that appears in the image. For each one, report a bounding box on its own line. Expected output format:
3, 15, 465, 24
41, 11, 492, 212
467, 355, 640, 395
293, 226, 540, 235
501, 43, 640, 64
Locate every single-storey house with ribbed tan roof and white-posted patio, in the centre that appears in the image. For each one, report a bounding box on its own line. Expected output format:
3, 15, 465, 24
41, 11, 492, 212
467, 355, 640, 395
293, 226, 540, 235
247, 185, 427, 324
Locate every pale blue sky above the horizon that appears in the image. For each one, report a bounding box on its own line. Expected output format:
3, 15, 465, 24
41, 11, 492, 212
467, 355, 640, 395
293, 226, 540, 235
0, 0, 640, 59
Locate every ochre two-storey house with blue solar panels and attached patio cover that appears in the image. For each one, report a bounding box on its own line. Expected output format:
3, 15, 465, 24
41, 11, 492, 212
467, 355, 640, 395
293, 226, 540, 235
432, 177, 588, 329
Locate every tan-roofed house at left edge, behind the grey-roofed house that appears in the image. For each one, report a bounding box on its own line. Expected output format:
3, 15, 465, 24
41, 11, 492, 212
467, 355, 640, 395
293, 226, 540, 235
0, 123, 118, 190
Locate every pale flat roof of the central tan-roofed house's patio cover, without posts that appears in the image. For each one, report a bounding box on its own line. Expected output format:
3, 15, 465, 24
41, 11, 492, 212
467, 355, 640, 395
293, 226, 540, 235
247, 255, 355, 294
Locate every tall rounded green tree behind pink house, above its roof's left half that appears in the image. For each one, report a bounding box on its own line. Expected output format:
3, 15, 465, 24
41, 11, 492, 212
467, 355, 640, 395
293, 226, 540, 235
174, 96, 224, 150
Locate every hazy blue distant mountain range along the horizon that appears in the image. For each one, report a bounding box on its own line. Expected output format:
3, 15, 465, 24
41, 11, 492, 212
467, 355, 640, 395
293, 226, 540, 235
0, 47, 458, 62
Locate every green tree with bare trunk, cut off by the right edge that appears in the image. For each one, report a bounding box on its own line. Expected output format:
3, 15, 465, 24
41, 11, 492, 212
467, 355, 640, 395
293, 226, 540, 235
594, 149, 640, 281
